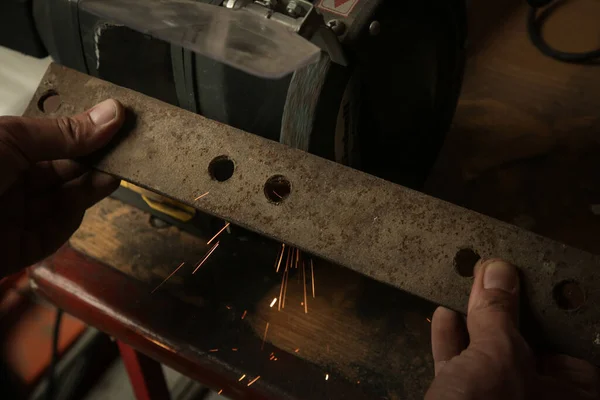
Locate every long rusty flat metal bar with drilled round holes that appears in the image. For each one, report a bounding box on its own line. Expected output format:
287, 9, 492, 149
26, 65, 600, 364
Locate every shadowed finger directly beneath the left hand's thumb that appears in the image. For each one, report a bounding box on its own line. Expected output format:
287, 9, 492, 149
26, 160, 89, 194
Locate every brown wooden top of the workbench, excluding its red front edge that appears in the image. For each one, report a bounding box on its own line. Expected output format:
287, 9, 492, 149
34, 0, 600, 399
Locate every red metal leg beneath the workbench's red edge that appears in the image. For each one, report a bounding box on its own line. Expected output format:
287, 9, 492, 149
117, 341, 171, 400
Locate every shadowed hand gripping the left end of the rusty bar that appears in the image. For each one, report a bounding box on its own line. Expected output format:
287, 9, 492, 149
0, 100, 125, 278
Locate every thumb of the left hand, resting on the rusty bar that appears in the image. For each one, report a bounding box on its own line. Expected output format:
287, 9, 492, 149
0, 99, 125, 170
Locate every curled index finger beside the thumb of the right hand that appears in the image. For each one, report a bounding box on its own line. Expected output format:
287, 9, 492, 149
431, 307, 468, 376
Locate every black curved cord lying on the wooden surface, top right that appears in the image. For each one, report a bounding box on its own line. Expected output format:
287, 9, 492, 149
527, 0, 600, 64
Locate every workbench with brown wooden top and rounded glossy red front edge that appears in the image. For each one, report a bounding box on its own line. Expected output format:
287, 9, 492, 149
31, 0, 600, 399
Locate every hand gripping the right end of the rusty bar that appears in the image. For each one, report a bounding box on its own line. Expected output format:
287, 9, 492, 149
425, 259, 600, 400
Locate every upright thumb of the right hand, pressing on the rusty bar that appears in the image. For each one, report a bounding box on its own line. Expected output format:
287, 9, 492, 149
467, 259, 519, 343
